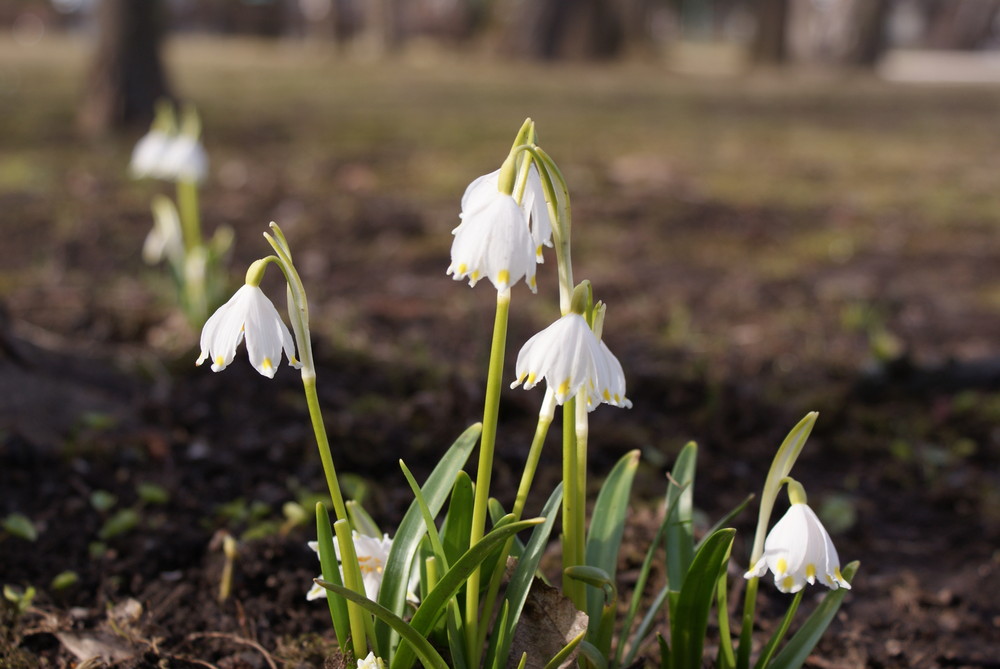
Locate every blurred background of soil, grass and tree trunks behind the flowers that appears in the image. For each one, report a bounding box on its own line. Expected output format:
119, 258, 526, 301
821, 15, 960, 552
0, 0, 1000, 667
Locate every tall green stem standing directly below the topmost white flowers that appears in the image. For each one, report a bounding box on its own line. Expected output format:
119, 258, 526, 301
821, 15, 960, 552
465, 288, 510, 666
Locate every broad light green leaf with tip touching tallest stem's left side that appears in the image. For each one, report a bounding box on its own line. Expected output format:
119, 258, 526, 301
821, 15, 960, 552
375, 423, 482, 661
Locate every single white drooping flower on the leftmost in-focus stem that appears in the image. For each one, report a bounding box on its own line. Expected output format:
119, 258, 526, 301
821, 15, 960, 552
196, 284, 299, 378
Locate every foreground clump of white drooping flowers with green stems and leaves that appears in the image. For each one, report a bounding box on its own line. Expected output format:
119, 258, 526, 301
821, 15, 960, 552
197, 119, 857, 669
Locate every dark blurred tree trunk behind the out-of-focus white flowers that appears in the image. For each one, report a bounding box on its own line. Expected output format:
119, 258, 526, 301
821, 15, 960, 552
79, 0, 169, 134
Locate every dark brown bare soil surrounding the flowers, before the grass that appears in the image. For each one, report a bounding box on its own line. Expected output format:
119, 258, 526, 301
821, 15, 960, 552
0, 37, 1000, 669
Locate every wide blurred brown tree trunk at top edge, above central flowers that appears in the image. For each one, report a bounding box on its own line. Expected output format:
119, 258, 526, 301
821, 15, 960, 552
504, 0, 625, 60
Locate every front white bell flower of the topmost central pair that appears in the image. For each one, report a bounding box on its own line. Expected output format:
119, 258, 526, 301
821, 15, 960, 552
447, 174, 536, 291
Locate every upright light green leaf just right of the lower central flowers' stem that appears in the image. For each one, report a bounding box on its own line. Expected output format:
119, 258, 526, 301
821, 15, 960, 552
586, 451, 639, 640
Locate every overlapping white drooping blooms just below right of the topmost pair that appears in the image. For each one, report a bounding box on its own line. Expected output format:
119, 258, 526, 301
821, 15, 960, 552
511, 312, 632, 411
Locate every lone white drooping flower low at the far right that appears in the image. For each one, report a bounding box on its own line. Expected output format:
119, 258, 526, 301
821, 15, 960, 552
744, 503, 851, 592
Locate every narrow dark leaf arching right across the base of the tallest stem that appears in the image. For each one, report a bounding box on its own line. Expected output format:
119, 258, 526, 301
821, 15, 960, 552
391, 516, 545, 669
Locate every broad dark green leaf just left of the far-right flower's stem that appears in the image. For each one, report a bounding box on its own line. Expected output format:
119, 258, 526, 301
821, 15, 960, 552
670, 528, 736, 667
